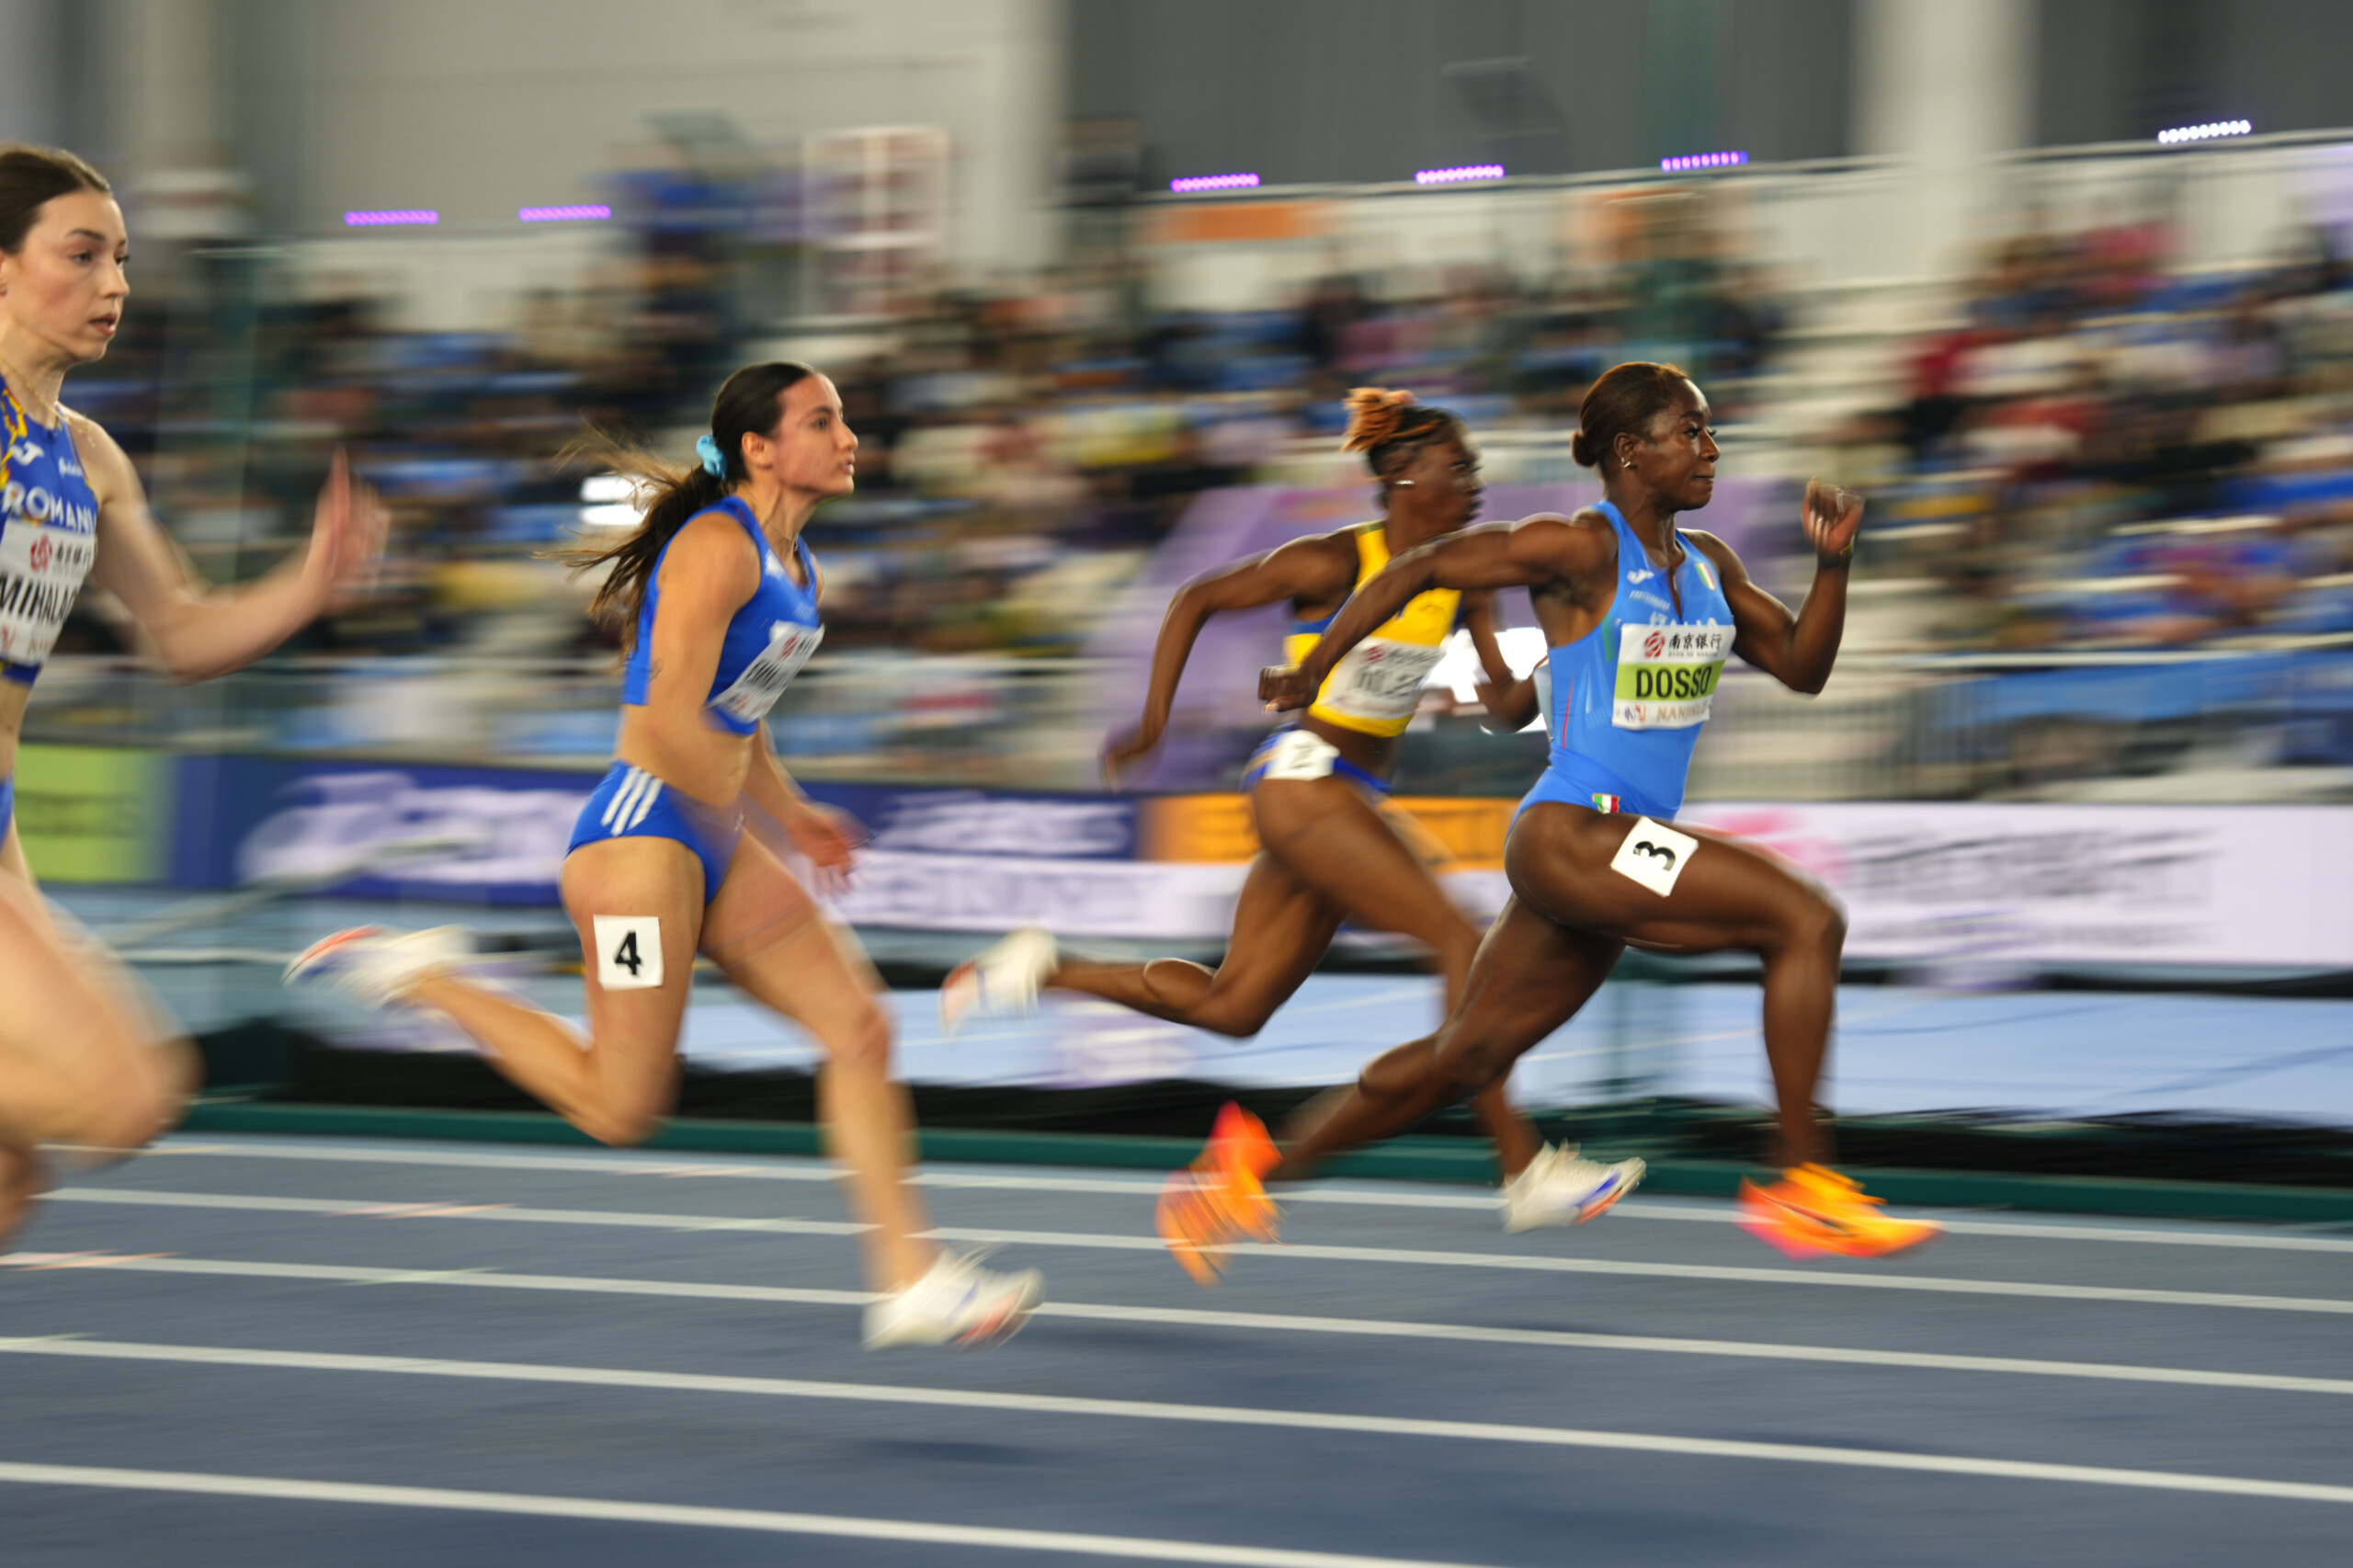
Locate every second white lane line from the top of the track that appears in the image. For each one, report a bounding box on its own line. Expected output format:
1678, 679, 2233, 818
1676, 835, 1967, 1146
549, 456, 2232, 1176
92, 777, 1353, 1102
47, 1187, 2353, 1316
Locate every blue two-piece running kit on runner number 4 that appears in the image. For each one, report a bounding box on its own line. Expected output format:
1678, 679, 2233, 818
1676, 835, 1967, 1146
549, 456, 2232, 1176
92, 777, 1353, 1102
564, 496, 826, 904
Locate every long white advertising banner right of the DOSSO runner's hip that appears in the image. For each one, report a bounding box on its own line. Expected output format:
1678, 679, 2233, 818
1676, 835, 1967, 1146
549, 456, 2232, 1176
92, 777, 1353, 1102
1677, 801, 2353, 968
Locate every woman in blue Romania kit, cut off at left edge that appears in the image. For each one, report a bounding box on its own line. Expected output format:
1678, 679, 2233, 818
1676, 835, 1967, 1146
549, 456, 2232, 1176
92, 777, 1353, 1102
0, 146, 383, 1238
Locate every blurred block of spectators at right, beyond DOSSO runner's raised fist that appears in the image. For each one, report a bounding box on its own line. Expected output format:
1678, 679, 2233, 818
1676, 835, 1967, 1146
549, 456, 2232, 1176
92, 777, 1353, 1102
1831, 210, 2353, 650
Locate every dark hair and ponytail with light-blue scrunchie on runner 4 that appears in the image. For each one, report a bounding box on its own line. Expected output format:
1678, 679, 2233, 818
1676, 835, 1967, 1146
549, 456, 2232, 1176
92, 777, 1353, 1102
555, 360, 816, 650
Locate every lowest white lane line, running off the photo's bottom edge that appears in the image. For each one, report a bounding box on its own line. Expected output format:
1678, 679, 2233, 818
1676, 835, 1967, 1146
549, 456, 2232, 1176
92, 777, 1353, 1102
0, 1462, 1471, 1568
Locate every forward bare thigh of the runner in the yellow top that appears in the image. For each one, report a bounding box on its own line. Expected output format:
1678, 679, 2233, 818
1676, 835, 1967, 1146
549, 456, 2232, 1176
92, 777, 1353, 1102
1249, 779, 1475, 947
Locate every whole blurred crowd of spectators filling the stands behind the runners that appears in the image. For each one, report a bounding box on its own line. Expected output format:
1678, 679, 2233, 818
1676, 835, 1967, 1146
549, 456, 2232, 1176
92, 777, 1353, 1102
41, 191, 2353, 682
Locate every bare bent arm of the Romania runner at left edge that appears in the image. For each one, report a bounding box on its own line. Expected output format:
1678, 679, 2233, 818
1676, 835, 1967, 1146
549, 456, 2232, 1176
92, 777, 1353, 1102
81, 428, 386, 680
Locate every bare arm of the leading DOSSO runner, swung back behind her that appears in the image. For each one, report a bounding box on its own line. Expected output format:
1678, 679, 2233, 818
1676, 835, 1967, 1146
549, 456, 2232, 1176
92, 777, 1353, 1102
1259, 513, 1617, 709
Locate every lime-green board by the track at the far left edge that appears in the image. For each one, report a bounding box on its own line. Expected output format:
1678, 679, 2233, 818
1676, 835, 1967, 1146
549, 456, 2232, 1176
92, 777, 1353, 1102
17, 746, 172, 883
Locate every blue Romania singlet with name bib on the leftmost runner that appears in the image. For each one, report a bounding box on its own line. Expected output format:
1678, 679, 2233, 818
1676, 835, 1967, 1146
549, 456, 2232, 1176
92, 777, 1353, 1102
0, 386, 99, 685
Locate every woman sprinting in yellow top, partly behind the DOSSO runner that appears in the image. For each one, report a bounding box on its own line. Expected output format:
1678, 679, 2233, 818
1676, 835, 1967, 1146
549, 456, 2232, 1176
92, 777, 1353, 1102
941, 386, 1643, 1261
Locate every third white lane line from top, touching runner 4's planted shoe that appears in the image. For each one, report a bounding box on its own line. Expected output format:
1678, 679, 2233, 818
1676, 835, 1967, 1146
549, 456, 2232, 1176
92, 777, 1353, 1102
0, 1253, 2353, 1396
